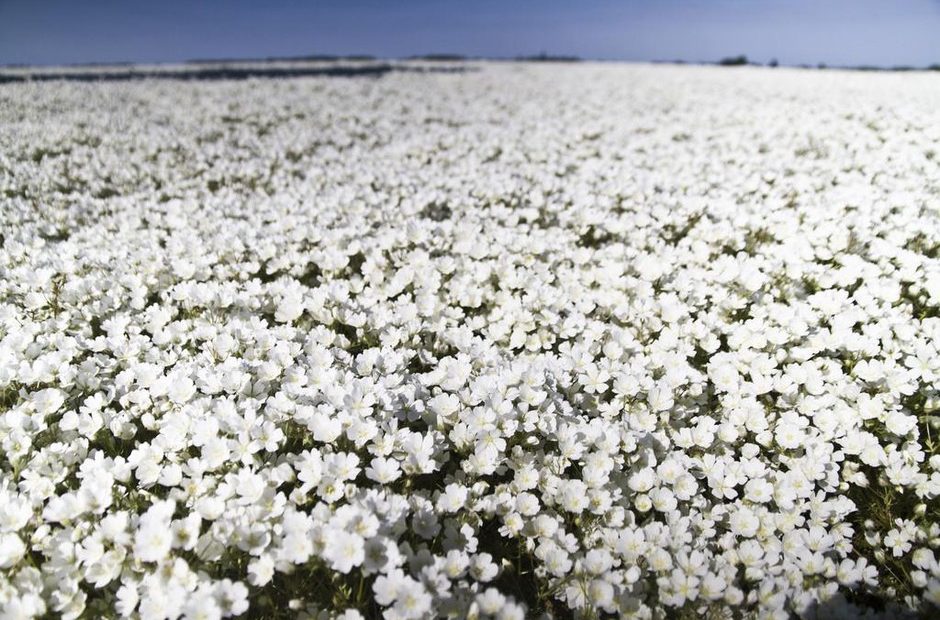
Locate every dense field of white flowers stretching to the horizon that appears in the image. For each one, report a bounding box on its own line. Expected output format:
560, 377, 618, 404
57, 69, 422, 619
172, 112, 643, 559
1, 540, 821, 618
0, 63, 940, 620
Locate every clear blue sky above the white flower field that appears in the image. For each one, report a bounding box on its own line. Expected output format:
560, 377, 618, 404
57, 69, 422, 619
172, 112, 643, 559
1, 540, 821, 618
0, 0, 940, 66
